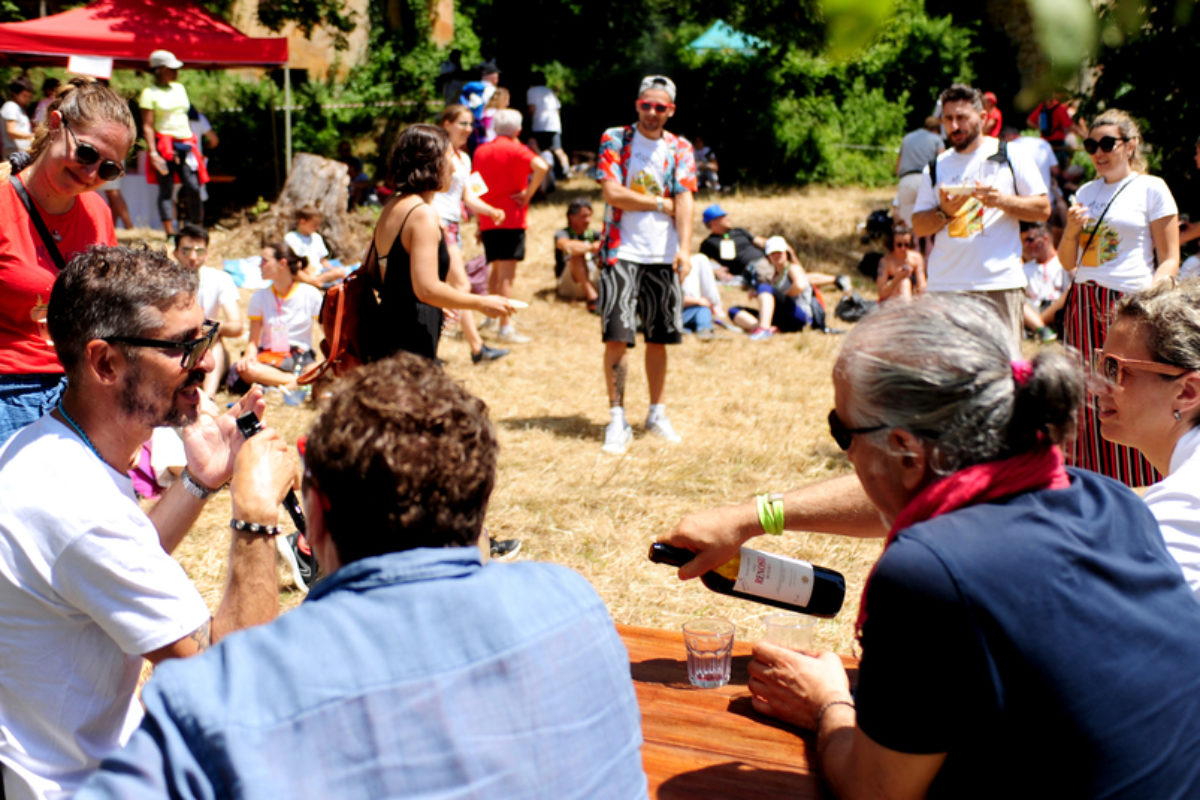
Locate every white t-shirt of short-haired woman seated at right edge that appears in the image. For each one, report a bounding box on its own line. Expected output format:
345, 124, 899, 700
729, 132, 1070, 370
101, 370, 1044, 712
1142, 428, 1200, 596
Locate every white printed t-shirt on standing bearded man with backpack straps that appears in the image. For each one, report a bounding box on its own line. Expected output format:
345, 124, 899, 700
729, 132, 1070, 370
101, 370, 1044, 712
913, 137, 1046, 291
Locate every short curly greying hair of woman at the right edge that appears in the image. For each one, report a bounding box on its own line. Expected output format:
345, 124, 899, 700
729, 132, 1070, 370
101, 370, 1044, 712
1112, 278, 1200, 426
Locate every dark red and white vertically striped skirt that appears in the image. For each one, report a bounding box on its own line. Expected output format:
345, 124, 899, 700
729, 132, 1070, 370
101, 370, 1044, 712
1063, 283, 1162, 486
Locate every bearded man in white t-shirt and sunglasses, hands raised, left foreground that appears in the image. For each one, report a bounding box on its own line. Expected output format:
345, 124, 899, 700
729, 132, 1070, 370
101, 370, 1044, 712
0, 247, 298, 798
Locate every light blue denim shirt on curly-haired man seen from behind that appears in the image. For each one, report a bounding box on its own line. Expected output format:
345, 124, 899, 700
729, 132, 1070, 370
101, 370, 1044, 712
77, 547, 647, 800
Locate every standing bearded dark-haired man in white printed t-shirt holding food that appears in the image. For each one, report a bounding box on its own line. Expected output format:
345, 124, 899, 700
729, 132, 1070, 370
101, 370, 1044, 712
912, 84, 1050, 342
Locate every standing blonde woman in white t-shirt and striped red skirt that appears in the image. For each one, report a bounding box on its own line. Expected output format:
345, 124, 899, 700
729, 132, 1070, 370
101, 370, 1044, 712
1058, 109, 1180, 486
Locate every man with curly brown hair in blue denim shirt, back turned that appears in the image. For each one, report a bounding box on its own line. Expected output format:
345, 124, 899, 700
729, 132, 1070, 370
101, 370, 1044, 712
77, 353, 647, 800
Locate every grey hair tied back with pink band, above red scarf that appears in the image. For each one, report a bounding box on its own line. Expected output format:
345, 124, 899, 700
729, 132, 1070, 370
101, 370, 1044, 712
834, 295, 1084, 475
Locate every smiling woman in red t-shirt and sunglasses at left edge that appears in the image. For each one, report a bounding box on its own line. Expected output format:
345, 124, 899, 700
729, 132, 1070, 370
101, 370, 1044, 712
0, 78, 136, 443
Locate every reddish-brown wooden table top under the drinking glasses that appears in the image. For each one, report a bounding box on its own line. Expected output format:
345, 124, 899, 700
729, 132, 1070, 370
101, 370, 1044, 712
617, 625, 857, 800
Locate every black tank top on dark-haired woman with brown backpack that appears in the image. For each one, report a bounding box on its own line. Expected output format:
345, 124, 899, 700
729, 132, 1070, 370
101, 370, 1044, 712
367, 204, 450, 361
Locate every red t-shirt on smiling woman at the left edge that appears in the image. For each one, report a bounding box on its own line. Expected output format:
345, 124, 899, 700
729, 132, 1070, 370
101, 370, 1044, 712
0, 181, 116, 375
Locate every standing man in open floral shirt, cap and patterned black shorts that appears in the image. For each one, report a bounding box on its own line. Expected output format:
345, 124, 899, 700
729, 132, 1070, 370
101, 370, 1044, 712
599, 76, 696, 455
